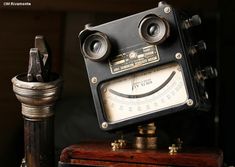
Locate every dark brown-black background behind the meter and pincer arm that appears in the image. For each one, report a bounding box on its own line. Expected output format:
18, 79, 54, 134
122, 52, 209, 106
0, 0, 235, 167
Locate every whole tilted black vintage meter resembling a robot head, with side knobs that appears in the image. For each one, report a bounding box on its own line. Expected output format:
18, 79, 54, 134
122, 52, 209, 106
79, 2, 216, 131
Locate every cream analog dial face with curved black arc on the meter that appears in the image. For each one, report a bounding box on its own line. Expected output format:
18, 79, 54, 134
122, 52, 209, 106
100, 63, 188, 123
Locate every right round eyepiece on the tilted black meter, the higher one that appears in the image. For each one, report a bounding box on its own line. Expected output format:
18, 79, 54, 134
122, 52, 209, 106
139, 15, 170, 44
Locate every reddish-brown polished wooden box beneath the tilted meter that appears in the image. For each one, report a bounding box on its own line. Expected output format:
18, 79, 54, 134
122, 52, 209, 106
59, 143, 223, 167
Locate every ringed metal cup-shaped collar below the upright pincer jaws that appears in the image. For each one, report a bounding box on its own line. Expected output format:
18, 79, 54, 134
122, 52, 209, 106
12, 74, 62, 120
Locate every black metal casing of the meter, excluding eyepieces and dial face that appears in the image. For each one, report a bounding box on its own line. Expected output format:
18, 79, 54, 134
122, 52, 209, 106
79, 1, 208, 131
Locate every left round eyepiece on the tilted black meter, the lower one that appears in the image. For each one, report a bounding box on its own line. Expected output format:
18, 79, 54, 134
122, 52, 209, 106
82, 32, 111, 61
